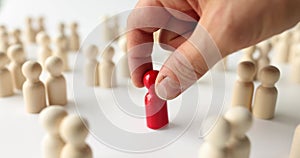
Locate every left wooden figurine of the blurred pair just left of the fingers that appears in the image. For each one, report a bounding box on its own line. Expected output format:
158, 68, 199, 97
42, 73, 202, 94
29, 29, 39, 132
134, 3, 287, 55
85, 45, 99, 86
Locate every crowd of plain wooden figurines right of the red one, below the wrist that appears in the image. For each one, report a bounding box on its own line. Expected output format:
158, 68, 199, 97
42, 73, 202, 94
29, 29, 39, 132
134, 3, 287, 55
199, 24, 300, 158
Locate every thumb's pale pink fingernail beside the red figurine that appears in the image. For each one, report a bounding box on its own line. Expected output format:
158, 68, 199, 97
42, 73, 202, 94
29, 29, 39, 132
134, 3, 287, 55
155, 77, 181, 100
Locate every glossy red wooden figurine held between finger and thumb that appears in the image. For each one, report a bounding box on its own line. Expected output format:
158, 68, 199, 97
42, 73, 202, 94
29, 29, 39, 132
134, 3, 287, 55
143, 70, 169, 129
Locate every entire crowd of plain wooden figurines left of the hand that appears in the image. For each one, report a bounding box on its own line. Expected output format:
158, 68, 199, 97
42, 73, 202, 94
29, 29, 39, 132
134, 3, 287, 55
0, 16, 129, 158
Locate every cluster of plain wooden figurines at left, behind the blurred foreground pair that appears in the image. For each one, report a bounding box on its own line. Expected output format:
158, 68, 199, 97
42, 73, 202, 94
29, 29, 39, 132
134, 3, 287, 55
0, 17, 80, 113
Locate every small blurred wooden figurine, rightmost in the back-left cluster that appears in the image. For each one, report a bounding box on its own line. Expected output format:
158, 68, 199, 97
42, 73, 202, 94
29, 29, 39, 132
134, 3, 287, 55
69, 22, 80, 52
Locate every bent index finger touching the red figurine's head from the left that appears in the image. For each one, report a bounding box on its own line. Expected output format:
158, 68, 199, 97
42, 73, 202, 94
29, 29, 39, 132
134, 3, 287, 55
127, 0, 170, 87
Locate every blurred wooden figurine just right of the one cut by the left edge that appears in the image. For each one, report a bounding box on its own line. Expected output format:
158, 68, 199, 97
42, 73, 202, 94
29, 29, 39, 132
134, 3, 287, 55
7, 45, 26, 90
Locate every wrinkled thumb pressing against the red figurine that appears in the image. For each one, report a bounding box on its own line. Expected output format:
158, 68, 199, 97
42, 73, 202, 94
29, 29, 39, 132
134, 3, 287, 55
155, 24, 222, 100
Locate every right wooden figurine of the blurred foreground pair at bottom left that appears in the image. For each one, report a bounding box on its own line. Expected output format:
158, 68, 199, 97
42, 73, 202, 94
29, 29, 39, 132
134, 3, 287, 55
60, 115, 93, 158
